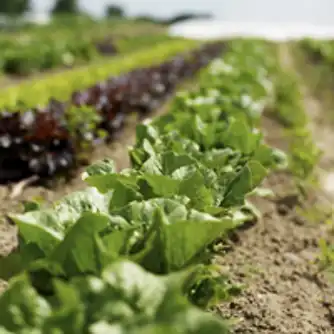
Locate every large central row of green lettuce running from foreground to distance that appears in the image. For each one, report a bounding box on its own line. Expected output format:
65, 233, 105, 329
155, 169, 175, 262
0, 41, 286, 334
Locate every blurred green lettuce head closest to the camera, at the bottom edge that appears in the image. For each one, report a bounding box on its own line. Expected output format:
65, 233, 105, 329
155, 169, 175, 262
0, 261, 228, 334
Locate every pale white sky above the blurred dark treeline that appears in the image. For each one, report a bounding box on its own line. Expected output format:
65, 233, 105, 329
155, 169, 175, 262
30, 0, 334, 24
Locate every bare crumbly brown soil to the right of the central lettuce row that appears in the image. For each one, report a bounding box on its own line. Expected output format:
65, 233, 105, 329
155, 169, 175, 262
217, 47, 334, 334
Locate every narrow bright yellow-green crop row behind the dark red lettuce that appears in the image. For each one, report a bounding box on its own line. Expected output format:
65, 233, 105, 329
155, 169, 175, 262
0, 39, 199, 110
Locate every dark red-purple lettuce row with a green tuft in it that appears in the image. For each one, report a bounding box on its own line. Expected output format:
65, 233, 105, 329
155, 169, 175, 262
0, 43, 223, 182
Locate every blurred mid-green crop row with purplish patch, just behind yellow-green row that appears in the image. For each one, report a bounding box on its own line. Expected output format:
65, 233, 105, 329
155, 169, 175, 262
0, 35, 171, 75
